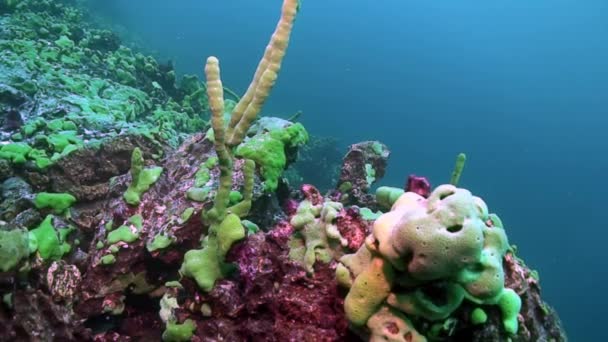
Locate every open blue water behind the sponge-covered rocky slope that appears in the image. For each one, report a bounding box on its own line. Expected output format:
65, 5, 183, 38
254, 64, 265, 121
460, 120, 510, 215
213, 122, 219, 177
91, 0, 608, 341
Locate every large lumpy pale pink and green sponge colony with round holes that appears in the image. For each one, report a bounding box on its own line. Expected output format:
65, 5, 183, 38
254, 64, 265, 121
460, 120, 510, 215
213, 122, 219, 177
337, 185, 521, 341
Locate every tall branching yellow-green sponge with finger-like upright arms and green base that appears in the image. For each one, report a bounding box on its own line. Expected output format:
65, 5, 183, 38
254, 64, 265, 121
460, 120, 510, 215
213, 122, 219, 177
180, 0, 299, 292
